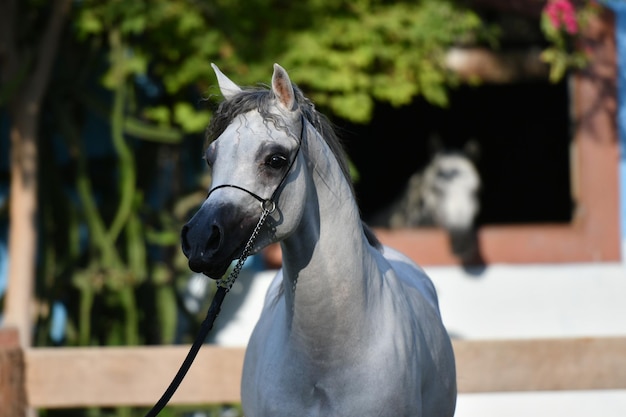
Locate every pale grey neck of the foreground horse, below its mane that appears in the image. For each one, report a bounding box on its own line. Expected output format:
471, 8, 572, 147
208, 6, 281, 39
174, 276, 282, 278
282, 127, 380, 358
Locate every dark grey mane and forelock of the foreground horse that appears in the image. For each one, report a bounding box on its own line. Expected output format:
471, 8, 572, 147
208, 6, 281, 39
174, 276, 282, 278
206, 84, 381, 248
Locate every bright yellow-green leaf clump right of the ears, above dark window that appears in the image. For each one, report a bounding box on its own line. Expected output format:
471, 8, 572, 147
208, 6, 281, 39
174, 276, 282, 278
282, 0, 489, 123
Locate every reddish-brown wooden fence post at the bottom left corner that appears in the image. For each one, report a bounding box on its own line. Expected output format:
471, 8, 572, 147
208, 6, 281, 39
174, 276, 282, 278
0, 327, 27, 417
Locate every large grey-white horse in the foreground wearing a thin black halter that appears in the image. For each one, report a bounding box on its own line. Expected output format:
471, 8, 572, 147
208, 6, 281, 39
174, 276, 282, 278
182, 64, 456, 417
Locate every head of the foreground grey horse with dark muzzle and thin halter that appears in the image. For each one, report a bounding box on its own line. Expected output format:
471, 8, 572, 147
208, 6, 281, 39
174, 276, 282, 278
181, 64, 306, 279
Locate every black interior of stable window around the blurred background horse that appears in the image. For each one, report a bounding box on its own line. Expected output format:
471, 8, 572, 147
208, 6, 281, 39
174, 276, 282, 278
338, 81, 573, 224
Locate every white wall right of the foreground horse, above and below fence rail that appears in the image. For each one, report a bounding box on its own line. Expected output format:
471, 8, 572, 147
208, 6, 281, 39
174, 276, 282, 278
426, 263, 626, 417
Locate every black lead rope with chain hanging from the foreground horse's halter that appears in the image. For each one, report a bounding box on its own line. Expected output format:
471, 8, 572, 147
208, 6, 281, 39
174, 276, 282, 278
145, 199, 276, 417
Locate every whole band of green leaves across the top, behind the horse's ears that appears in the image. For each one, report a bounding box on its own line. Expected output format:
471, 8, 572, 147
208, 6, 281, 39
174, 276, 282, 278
76, 0, 494, 125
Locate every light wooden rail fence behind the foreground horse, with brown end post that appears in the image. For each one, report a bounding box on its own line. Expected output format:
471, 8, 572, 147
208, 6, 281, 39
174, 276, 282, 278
0, 330, 626, 417
